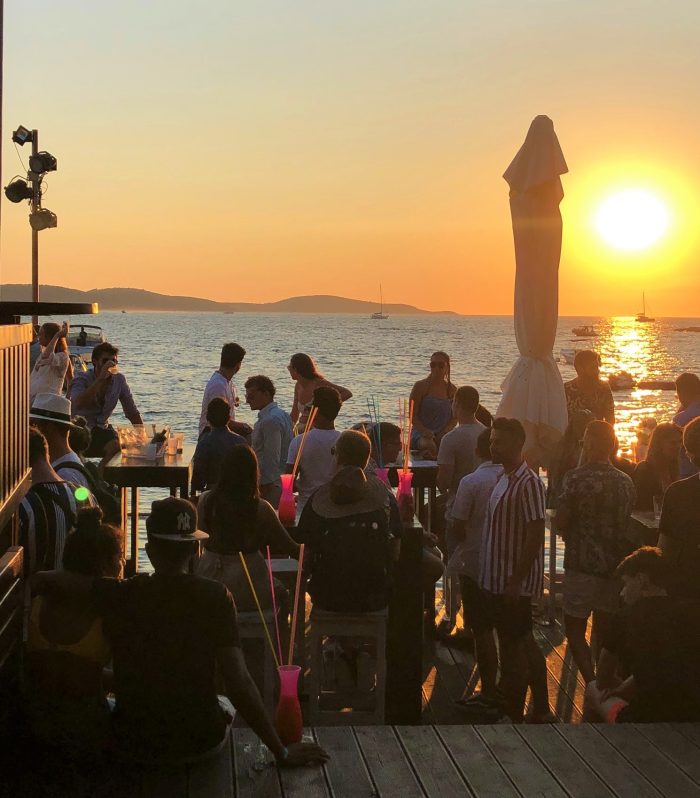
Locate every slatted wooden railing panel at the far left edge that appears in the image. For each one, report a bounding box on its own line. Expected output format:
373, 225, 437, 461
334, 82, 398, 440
0, 324, 32, 540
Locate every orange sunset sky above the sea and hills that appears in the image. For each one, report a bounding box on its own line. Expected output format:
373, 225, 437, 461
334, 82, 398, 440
0, 0, 700, 316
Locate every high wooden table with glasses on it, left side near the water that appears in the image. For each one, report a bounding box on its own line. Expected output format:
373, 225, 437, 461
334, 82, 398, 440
104, 444, 195, 576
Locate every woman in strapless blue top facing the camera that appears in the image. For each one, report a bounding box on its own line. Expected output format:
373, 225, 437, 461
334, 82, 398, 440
410, 352, 457, 460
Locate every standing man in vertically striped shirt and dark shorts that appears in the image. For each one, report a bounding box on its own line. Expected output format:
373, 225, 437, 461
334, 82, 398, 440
480, 418, 549, 723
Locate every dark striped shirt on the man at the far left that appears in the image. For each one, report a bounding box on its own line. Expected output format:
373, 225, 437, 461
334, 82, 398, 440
19, 482, 97, 575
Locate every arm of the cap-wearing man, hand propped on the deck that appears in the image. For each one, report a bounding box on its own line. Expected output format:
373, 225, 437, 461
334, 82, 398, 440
216, 646, 329, 767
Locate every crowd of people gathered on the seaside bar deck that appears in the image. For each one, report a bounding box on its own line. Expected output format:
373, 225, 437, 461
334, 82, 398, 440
6, 332, 700, 788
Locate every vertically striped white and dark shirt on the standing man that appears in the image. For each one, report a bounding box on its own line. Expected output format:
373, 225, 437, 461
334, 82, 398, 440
480, 462, 545, 596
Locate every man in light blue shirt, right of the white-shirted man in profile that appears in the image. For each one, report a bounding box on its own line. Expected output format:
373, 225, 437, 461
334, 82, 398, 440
245, 374, 292, 508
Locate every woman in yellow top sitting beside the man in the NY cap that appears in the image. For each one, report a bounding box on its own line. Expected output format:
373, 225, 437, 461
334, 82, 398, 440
25, 508, 123, 754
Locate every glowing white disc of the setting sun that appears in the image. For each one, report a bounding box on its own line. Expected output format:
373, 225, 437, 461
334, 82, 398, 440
594, 189, 670, 252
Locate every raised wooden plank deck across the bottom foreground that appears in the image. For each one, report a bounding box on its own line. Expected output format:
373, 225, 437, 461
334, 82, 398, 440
232, 724, 700, 798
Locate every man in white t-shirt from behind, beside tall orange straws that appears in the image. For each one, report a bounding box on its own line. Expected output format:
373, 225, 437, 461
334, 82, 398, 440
287, 386, 342, 513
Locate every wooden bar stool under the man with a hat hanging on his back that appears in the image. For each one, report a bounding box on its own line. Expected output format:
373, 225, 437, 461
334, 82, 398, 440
309, 607, 387, 726
